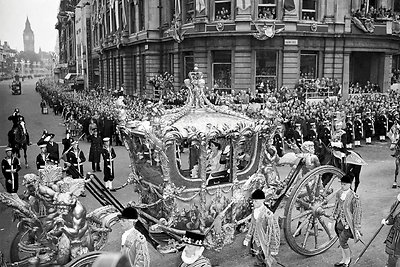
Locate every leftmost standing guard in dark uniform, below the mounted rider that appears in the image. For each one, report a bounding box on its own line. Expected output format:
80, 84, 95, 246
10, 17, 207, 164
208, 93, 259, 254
1, 147, 21, 193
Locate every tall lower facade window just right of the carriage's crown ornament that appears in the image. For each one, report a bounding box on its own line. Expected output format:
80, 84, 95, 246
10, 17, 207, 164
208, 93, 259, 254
212, 51, 232, 93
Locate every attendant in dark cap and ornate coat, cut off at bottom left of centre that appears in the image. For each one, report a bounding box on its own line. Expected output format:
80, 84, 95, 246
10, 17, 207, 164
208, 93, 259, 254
119, 207, 150, 267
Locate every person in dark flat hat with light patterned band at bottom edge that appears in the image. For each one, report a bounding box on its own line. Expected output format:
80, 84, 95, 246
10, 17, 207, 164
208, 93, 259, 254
179, 231, 211, 267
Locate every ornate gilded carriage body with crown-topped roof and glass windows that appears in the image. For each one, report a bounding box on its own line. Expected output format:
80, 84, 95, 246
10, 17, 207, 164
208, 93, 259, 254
120, 67, 275, 249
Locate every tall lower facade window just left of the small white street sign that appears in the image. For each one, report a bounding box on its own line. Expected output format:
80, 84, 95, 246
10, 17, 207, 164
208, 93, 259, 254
256, 51, 277, 93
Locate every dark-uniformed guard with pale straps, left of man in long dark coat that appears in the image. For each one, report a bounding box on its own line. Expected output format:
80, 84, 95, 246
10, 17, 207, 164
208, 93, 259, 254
65, 140, 86, 179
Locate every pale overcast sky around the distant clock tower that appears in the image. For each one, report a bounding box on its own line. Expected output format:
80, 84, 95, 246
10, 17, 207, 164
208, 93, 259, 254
0, 0, 60, 52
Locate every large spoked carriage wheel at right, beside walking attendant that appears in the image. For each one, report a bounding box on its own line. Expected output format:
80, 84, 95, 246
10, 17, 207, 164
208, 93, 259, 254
283, 165, 344, 256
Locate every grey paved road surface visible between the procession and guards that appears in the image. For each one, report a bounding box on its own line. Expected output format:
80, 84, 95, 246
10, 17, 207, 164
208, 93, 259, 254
0, 80, 400, 267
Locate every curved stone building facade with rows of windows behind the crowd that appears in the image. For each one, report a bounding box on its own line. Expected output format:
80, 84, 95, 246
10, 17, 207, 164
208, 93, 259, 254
91, 0, 400, 97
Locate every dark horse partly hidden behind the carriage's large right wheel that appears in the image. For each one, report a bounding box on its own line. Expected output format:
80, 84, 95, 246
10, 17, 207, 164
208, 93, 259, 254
314, 140, 366, 192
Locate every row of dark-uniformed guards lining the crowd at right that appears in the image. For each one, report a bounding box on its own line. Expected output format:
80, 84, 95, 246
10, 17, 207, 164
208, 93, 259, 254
273, 111, 400, 157
